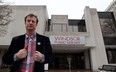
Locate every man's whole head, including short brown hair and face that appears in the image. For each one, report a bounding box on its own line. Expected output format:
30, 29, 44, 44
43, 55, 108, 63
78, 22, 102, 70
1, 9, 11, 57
25, 14, 38, 32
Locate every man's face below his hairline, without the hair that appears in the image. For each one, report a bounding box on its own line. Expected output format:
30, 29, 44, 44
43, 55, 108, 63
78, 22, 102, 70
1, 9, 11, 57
25, 16, 37, 31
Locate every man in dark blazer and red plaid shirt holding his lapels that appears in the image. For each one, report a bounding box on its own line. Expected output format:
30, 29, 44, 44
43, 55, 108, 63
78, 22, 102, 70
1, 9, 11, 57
2, 14, 53, 72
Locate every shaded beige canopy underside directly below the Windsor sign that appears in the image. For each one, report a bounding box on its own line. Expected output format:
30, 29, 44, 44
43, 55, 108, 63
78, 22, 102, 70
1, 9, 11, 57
52, 44, 90, 53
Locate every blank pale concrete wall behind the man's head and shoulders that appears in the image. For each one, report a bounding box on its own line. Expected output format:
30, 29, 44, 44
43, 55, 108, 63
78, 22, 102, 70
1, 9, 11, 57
0, 5, 48, 45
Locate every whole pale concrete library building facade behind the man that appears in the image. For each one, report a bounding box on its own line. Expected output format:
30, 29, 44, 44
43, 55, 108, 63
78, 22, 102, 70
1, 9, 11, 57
0, 3, 116, 70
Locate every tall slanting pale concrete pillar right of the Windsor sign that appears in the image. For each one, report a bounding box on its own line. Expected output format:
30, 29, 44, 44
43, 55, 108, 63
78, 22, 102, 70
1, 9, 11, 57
85, 7, 108, 70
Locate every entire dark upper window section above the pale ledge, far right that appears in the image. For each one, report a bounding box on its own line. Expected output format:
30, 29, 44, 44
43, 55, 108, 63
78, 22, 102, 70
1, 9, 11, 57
98, 12, 116, 45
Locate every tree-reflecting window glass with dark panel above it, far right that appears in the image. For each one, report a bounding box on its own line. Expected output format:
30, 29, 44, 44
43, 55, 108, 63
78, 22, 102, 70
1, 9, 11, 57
98, 12, 116, 36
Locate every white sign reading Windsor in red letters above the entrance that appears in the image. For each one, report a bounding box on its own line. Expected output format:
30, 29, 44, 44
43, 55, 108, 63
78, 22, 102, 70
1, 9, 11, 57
50, 36, 85, 44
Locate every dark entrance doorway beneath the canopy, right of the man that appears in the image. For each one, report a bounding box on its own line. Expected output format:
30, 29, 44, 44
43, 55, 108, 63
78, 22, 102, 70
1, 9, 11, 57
50, 52, 85, 70
